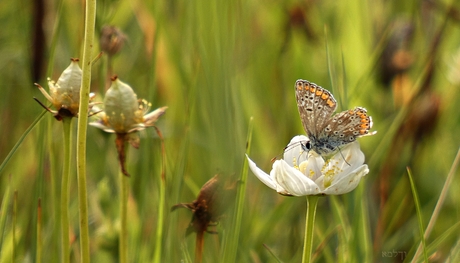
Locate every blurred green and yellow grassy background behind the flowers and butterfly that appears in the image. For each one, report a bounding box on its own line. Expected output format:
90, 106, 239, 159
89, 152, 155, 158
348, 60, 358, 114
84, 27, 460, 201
0, 0, 460, 262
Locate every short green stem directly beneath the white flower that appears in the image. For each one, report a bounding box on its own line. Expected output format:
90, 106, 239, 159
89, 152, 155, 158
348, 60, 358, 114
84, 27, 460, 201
302, 195, 319, 263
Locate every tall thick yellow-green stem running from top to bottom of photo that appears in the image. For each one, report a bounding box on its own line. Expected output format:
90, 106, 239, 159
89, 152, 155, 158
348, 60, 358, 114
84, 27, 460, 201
77, 0, 96, 263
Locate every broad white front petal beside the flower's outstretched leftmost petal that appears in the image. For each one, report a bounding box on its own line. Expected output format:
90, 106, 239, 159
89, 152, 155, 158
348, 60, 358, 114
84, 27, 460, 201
270, 160, 320, 196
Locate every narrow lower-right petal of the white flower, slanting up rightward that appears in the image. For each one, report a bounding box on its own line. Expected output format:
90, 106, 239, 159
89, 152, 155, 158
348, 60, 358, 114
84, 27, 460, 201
322, 164, 369, 195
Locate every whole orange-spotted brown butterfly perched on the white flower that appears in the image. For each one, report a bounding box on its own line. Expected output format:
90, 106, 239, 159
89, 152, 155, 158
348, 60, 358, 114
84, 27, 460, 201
295, 80, 373, 155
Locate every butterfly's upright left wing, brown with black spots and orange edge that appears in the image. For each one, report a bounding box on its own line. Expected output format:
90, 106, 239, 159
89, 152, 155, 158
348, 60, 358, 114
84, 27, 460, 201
295, 79, 337, 140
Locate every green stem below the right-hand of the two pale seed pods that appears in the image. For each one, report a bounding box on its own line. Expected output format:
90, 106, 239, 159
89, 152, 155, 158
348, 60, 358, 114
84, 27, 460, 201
119, 165, 129, 263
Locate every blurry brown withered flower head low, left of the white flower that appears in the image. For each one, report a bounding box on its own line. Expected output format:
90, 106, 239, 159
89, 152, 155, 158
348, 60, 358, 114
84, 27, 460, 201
171, 174, 236, 234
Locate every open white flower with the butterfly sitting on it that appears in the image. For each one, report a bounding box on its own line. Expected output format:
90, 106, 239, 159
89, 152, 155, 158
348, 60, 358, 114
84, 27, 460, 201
248, 135, 369, 196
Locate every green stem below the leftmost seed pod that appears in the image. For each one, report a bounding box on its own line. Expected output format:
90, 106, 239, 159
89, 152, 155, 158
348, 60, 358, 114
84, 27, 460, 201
60, 117, 72, 263
